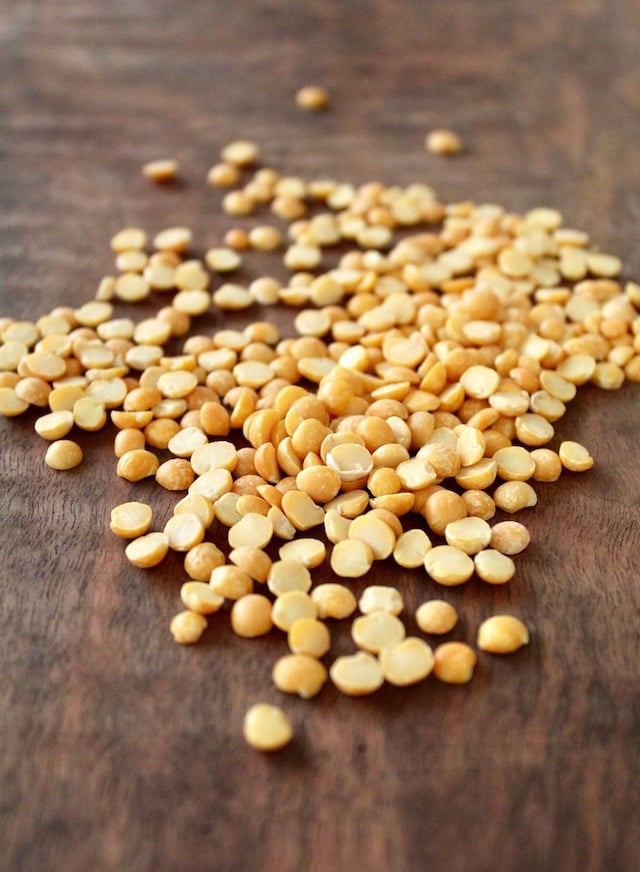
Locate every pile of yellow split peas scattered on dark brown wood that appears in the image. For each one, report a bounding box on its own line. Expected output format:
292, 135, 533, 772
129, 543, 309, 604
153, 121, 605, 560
0, 129, 640, 750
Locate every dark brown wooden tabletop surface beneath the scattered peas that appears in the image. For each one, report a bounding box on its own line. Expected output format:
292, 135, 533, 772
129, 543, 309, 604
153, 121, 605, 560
0, 0, 640, 872
